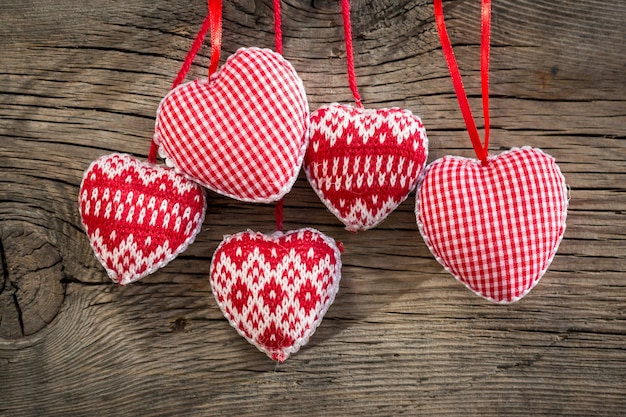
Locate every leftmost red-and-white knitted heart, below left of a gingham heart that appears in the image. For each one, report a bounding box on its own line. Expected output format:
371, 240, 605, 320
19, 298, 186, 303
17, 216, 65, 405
79, 153, 206, 285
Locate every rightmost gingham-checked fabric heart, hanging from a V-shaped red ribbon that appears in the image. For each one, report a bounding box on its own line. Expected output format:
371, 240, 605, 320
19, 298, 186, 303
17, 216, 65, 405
416, 147, 568, 303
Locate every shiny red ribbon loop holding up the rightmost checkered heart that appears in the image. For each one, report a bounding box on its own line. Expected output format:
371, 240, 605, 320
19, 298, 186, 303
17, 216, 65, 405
434, 0, 491, 163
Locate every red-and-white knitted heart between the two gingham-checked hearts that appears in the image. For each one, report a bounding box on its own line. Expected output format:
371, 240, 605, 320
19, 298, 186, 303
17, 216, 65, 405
304, 104, 428, 232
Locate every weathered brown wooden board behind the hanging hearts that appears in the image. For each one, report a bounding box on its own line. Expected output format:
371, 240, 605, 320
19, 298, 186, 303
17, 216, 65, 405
0, 0, 626, 416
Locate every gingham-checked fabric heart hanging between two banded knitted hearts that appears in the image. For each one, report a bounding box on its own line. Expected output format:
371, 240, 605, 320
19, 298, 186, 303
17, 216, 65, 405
154, 48, 309, 203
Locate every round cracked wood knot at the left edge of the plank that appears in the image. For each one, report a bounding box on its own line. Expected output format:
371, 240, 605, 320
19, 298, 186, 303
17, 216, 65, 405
0, 221, 65, 339
